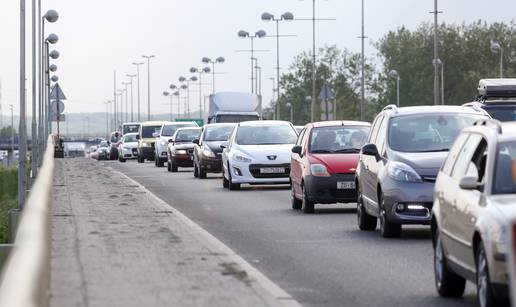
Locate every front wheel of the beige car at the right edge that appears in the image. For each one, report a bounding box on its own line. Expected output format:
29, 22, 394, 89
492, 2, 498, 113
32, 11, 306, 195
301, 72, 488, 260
476, 242, 498, 307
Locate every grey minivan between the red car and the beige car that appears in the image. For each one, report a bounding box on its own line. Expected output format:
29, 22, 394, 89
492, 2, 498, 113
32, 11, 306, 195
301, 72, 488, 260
356, 105, 486, 238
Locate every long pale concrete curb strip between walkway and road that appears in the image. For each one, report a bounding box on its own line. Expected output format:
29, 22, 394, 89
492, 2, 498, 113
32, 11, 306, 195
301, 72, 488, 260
109, 167, 302, 307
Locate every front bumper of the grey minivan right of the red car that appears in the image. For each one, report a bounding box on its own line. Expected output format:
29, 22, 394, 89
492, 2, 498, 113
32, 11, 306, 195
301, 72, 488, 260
382, 177, 435, 224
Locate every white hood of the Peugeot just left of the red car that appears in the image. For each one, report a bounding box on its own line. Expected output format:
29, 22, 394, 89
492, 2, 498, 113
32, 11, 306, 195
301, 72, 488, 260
232, 144, 294, 164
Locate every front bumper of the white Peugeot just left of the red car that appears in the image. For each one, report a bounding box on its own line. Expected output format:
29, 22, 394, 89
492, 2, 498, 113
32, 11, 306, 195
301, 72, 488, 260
230, 162, 290, 184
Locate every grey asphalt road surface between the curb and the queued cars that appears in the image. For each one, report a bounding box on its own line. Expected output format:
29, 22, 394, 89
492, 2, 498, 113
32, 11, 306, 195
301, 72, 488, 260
107, 161, 476, 307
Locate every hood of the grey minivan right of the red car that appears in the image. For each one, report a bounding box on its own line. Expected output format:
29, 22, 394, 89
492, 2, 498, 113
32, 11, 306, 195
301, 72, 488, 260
389, 151, 448, 176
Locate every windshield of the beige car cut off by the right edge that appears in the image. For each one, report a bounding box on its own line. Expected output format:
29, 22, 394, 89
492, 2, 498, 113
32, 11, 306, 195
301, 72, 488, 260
493, 142, 516, 194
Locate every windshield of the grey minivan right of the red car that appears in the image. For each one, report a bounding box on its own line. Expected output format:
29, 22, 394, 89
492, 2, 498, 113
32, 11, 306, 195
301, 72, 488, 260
388, 113, 481, 152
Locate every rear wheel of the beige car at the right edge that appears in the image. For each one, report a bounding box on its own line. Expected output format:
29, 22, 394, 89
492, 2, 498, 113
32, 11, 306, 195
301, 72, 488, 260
434, 229, 466, 297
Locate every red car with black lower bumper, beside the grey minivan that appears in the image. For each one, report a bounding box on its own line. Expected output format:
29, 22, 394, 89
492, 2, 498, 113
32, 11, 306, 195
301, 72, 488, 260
290, 121, 371, 213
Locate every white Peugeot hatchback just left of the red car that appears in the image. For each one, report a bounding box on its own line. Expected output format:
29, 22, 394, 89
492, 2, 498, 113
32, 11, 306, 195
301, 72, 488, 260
221, 121, 297, 190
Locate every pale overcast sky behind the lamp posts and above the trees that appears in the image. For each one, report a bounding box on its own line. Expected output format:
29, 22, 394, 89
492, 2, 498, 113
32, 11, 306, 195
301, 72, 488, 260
0, 0, 516, 118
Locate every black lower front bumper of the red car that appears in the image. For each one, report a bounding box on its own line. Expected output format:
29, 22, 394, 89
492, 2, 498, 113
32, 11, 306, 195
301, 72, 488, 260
304, 174, 357, 204
